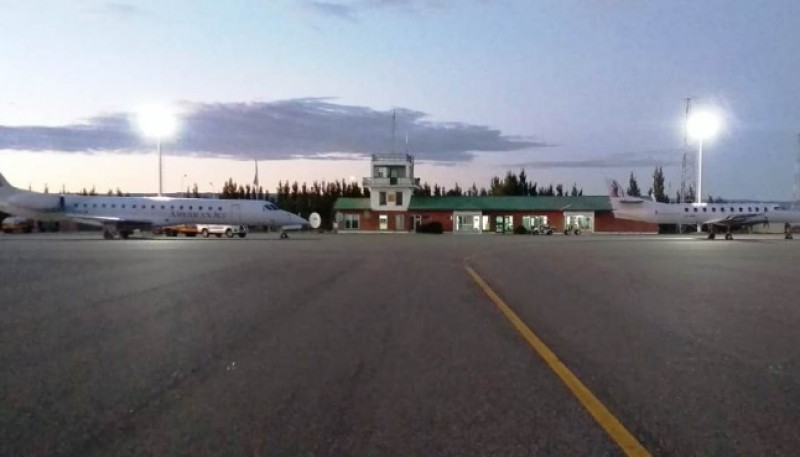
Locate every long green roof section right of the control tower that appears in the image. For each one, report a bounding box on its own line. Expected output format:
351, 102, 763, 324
408, 196, 611, 211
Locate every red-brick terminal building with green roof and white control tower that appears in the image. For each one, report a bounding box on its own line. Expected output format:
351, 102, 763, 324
334, 154, 658, 233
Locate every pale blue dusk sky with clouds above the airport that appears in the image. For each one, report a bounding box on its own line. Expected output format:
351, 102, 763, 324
0, 0, 800, 200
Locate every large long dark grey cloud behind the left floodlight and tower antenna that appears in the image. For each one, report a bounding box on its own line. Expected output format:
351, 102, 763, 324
0, 98, 549, 162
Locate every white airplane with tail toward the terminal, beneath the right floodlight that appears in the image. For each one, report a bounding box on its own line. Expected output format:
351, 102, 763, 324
609, 180, 800, 240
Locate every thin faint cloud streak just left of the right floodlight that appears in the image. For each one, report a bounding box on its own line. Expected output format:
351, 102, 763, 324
510, 149, 682, 169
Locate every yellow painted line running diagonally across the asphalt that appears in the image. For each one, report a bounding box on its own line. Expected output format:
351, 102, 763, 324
464, 265, 650, 456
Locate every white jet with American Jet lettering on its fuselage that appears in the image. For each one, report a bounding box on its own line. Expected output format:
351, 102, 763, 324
0, 174, 309, 239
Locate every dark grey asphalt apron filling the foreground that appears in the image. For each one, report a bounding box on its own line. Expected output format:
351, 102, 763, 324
0, 233, 800, 456
